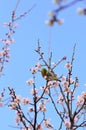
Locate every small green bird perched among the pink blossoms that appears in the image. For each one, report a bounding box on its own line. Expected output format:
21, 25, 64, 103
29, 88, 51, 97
41, 68, 58, 81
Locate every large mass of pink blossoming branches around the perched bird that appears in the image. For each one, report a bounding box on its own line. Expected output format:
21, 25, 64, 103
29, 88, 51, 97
9, 44, 86, 130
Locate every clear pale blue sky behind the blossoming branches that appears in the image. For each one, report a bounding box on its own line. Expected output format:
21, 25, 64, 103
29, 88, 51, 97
0, 0, 86, 130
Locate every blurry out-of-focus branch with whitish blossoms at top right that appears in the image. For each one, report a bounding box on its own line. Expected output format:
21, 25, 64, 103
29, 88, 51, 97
45, 0, 86, 26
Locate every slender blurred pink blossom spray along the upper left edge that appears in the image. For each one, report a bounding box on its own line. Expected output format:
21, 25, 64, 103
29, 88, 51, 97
0, 12, 18, 75
